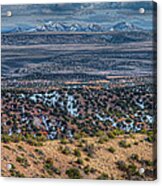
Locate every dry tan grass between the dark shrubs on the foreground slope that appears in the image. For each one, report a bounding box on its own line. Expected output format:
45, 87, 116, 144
2, 134, 156, 180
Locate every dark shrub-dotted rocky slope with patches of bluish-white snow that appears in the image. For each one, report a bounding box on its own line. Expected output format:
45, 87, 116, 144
2, 81, 156, 140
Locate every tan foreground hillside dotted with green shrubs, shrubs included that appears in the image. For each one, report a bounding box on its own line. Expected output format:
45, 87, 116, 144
2, 134, 156, 180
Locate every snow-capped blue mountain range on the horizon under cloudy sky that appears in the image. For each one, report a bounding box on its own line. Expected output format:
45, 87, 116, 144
2, 21, 142, 33
